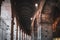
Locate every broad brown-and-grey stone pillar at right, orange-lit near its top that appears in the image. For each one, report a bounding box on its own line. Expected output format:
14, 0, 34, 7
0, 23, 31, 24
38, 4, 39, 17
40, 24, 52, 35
41, 4, 53, 40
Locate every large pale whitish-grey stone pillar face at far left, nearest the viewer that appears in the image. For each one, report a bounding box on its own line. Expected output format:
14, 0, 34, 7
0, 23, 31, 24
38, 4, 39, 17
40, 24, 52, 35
0, 0, 11, 40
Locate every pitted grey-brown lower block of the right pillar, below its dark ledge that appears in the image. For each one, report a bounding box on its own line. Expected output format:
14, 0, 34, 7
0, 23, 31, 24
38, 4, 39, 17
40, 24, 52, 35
41, 24, 52, 40
